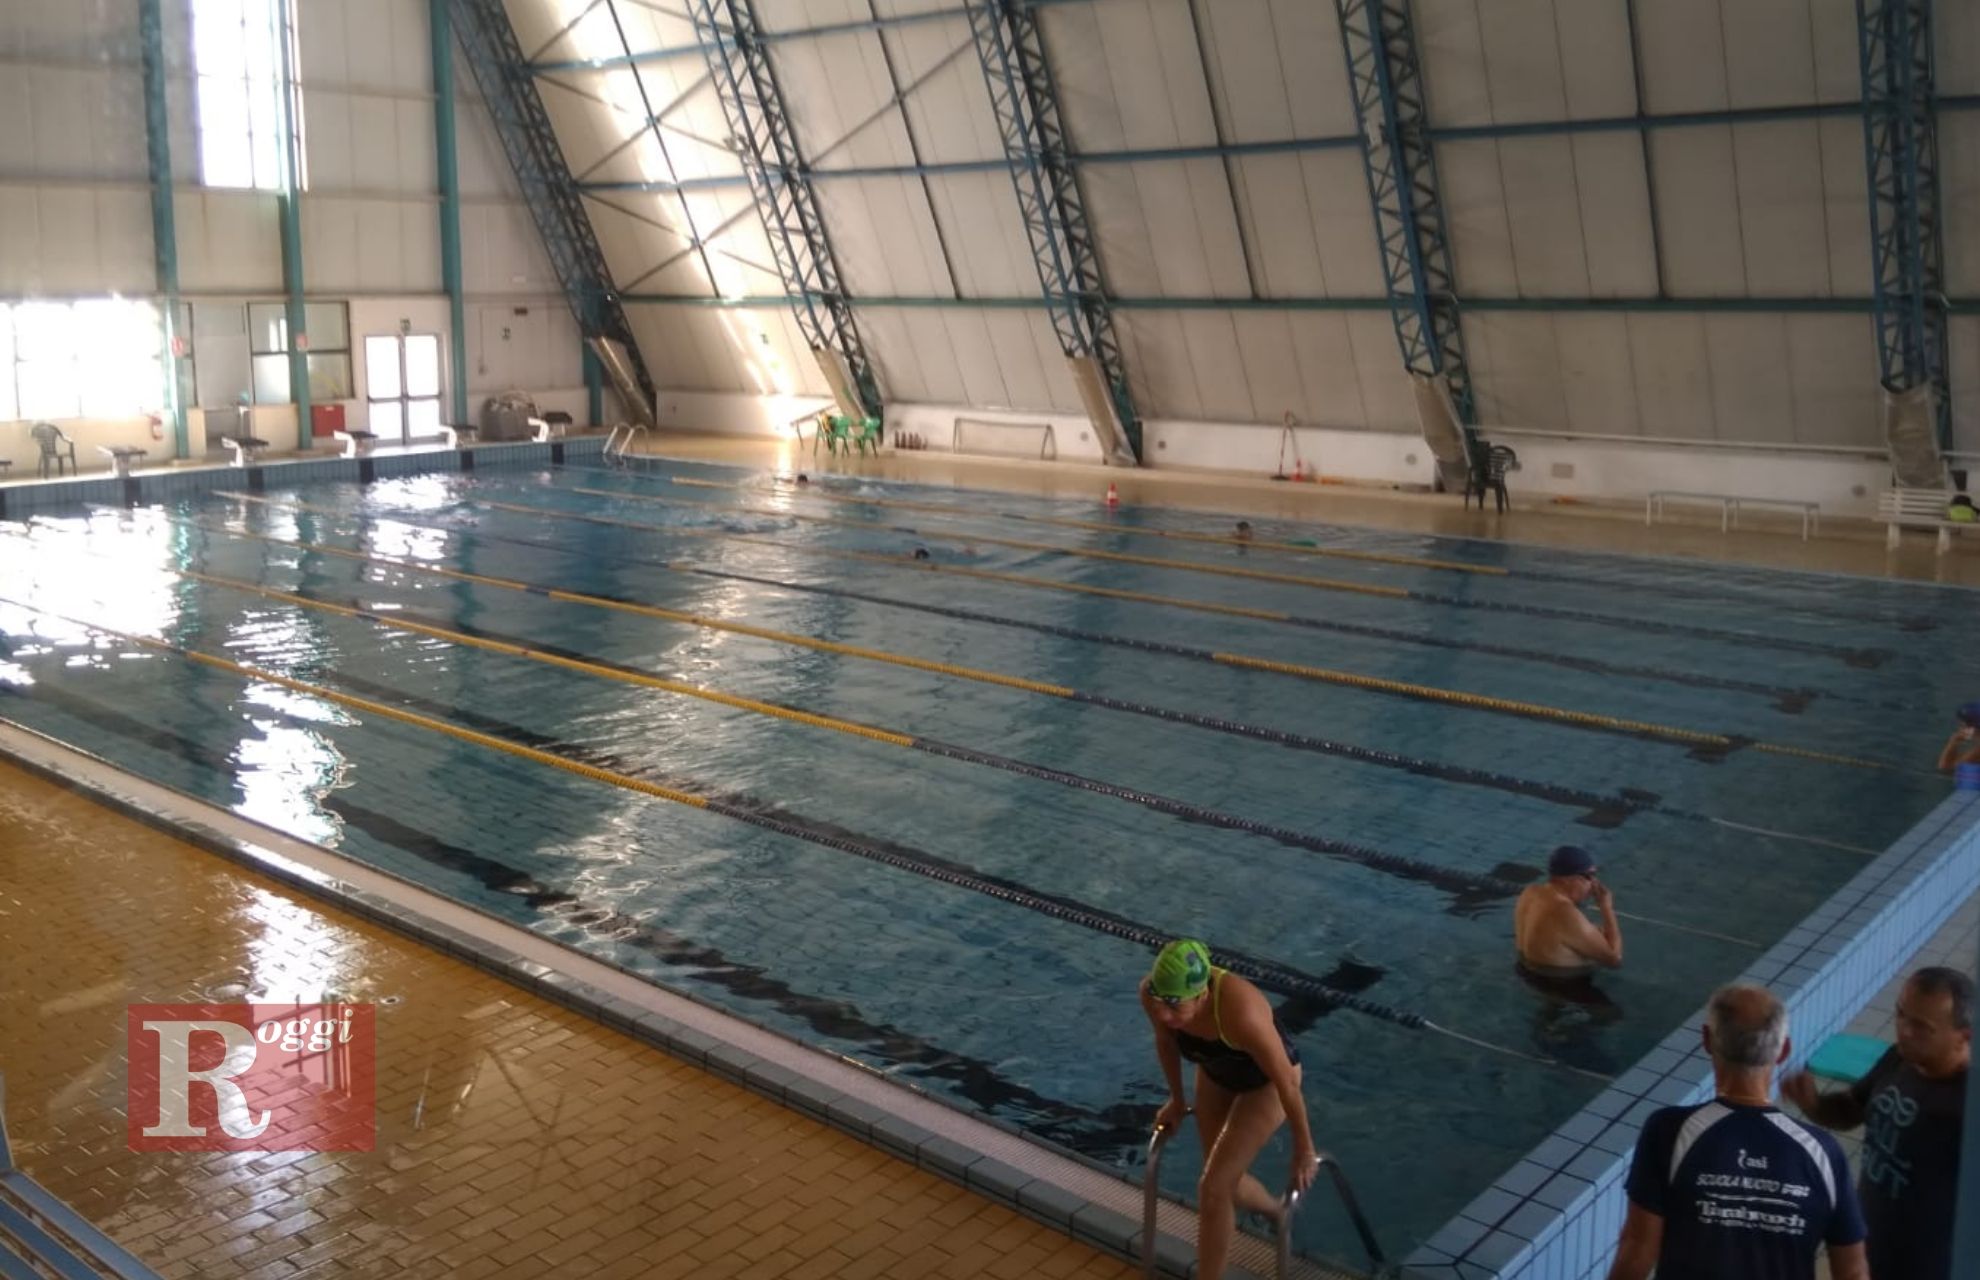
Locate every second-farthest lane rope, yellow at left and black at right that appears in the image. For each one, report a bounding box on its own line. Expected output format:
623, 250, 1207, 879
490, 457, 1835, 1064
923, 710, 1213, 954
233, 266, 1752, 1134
550, 471, 1893, 670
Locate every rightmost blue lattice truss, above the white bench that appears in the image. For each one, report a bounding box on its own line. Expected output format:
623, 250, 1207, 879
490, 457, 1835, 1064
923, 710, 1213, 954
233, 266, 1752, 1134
1857, 0, 1952, 450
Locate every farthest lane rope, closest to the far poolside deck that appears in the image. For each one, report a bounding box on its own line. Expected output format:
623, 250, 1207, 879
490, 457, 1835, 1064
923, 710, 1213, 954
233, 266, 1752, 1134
641, 458, 1938, 632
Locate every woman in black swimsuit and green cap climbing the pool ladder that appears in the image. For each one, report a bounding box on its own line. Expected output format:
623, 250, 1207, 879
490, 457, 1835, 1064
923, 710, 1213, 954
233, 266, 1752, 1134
1140, 937, 1321, 1280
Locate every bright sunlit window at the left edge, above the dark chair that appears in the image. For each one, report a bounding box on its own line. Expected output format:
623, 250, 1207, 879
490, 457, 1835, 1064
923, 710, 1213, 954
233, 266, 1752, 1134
0, 297, 164, 422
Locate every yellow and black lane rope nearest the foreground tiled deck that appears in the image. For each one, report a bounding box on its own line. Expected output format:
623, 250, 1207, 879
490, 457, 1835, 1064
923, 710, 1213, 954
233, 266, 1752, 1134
0, 596, 1610, 1082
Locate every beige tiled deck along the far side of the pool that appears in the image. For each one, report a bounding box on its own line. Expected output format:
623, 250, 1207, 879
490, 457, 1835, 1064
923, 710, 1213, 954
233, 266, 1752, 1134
642, 432, 1980, 587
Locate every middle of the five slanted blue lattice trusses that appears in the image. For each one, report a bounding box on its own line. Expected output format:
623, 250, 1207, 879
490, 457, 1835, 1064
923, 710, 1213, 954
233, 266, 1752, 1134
966, 0, 1140, 464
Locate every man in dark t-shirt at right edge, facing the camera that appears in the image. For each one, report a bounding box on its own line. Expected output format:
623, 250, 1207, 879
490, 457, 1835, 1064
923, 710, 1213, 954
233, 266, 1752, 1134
1780, 969, 1974, 1280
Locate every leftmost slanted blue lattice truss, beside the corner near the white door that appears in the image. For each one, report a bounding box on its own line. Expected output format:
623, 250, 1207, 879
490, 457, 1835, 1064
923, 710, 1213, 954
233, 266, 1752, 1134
449, 0, 655, 414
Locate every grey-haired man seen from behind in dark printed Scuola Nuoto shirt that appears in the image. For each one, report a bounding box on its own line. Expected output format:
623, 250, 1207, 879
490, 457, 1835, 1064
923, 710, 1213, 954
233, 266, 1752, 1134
1610, 987, 1869, 1280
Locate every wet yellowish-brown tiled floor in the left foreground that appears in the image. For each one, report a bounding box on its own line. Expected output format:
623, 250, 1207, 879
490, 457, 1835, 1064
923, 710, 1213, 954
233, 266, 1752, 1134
0, 765, 1133, 1280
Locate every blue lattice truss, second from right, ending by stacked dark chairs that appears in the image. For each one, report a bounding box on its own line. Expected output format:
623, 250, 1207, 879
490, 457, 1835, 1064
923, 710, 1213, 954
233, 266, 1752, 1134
1335, 0, 1477, 438
